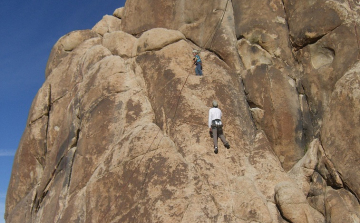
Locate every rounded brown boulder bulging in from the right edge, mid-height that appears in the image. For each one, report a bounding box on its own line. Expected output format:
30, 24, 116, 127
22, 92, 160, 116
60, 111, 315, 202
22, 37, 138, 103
322, 64, 360, 199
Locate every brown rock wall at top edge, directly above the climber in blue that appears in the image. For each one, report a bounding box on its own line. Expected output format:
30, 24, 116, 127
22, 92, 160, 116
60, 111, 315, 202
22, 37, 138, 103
122, 0, 241, 71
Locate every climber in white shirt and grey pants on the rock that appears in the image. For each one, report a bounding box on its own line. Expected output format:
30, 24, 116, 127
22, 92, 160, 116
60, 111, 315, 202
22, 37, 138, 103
209, 101, 230, 154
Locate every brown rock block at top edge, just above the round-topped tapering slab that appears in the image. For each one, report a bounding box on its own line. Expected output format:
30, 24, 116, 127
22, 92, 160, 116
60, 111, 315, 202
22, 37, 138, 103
231, 0, 294, 64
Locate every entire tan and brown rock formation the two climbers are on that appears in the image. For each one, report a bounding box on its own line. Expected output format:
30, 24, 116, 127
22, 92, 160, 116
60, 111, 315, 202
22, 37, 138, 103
5, 0, 360, 223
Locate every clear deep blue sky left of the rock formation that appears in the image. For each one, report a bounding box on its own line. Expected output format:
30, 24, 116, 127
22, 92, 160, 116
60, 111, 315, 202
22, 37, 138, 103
0, 0, 125, 223
